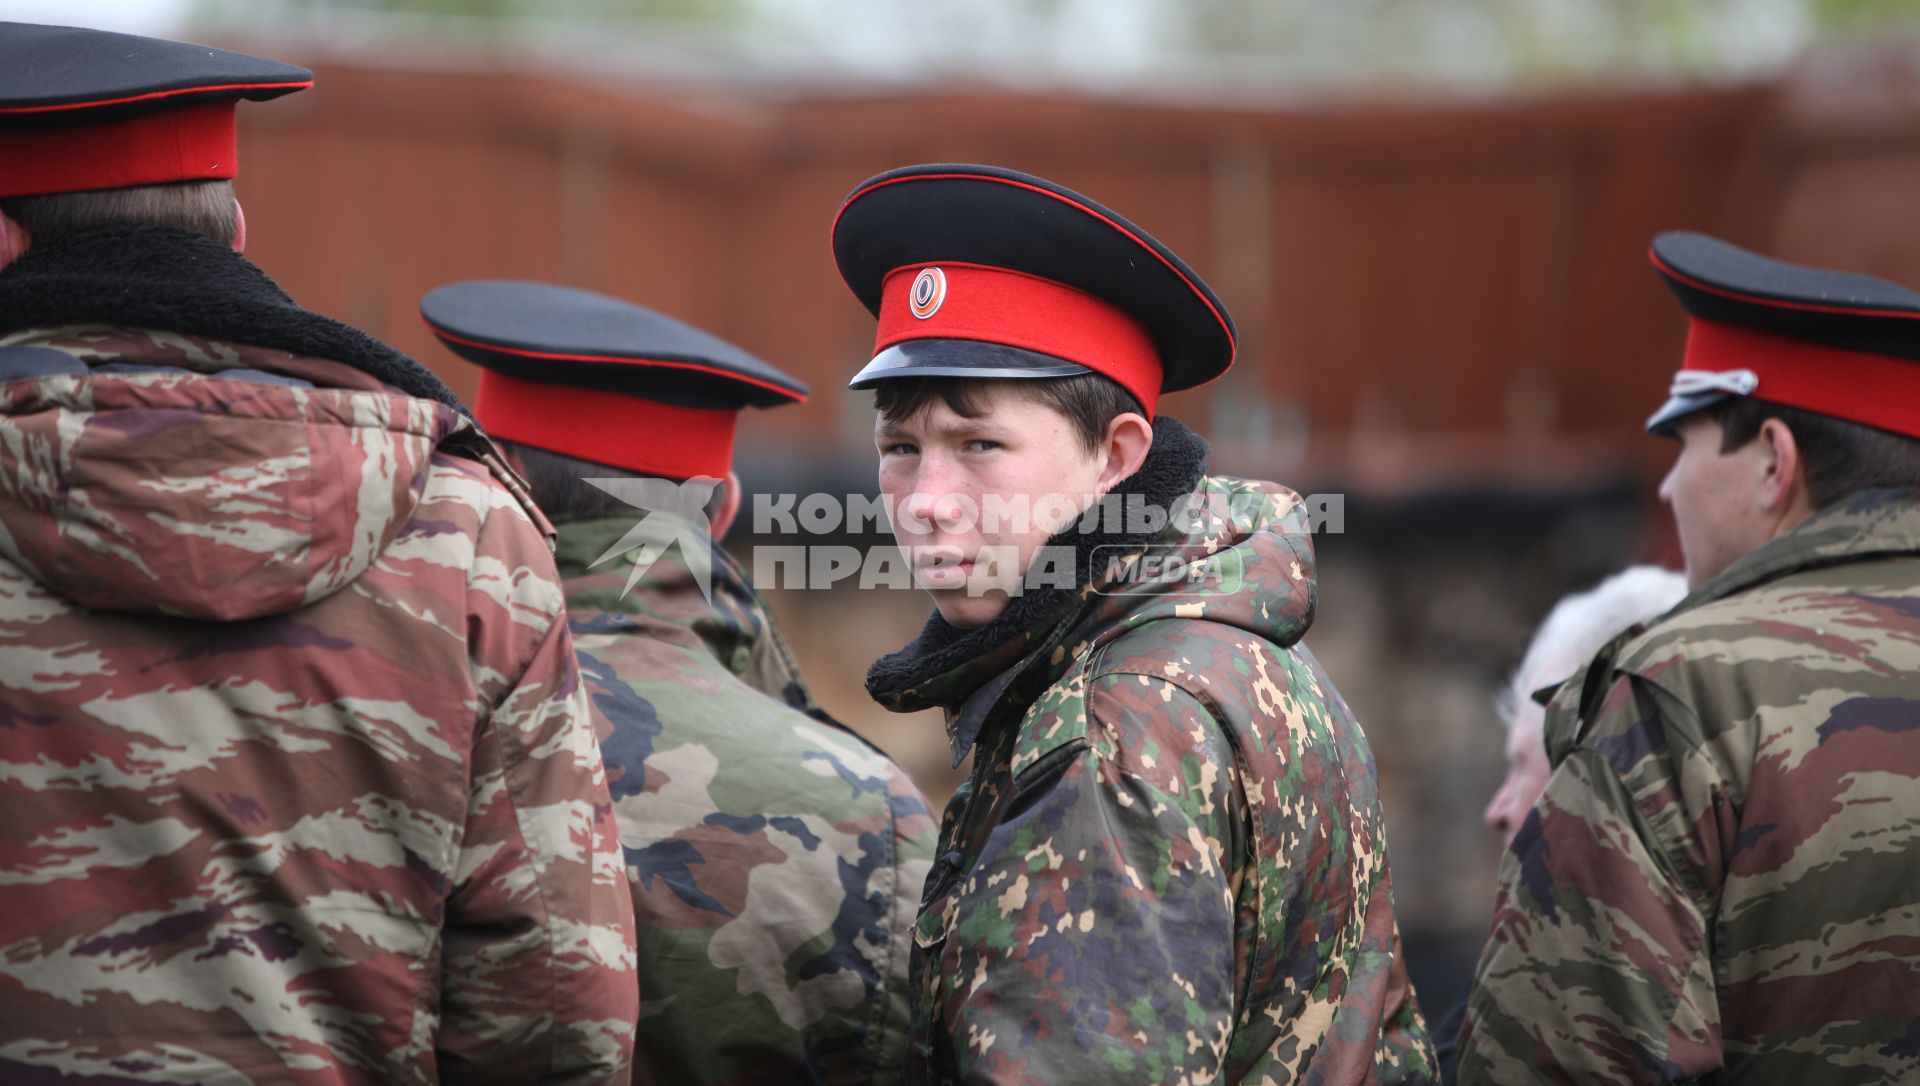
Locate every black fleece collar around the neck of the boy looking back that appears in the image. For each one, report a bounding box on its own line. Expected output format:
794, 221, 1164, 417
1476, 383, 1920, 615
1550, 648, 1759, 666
866, 414, 1210, 766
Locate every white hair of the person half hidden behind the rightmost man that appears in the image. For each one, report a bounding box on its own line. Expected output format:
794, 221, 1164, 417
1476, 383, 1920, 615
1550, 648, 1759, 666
1494, 566, 1686, 727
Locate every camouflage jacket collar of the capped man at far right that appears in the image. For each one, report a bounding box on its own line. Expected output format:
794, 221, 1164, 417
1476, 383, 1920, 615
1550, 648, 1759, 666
1674, 487, 1920, 626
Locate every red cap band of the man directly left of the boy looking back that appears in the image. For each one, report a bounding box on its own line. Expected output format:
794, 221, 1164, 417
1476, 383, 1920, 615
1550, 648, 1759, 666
474, 370, 739, 480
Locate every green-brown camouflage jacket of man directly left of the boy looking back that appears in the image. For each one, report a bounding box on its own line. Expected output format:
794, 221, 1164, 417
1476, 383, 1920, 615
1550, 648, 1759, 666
557, 510, 935, 1086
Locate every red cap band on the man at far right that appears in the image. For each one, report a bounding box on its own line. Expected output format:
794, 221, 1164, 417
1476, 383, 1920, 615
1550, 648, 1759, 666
1682, 317, 1920, 437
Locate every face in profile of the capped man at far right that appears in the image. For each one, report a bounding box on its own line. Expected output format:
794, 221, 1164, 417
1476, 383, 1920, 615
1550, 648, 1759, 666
1661, 413, 1768, 589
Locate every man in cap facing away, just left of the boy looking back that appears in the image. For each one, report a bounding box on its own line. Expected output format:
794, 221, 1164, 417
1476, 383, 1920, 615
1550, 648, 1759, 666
432, 282, 935, 1086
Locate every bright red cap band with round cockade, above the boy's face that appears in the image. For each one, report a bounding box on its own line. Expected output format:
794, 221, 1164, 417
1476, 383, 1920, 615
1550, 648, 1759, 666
874, 263, 1162, 418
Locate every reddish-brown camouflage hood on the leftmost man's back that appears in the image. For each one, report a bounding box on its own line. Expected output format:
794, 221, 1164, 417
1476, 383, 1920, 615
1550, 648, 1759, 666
0, 328, 484, 622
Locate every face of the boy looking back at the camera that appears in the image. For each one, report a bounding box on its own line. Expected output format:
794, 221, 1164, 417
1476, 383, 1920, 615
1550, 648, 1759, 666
874, 388, 1106, 627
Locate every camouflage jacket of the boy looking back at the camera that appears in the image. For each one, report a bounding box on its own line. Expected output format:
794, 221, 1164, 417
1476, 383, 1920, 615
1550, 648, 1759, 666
879, 466, 1432, 1084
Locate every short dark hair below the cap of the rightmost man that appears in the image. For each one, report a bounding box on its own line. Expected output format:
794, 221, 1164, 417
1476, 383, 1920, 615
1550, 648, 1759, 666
1707, 395, 1920, 508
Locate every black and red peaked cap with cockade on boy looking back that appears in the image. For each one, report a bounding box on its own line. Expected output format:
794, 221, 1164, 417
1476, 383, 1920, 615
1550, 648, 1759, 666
833, 163, 1235, 414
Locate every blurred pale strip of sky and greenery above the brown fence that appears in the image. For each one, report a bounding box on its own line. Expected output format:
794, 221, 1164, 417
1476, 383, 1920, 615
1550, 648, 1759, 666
196, 0, 1920, 88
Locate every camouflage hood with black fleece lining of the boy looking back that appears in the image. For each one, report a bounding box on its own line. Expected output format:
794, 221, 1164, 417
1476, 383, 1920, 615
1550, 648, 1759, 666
868, 416, 1313, 764
